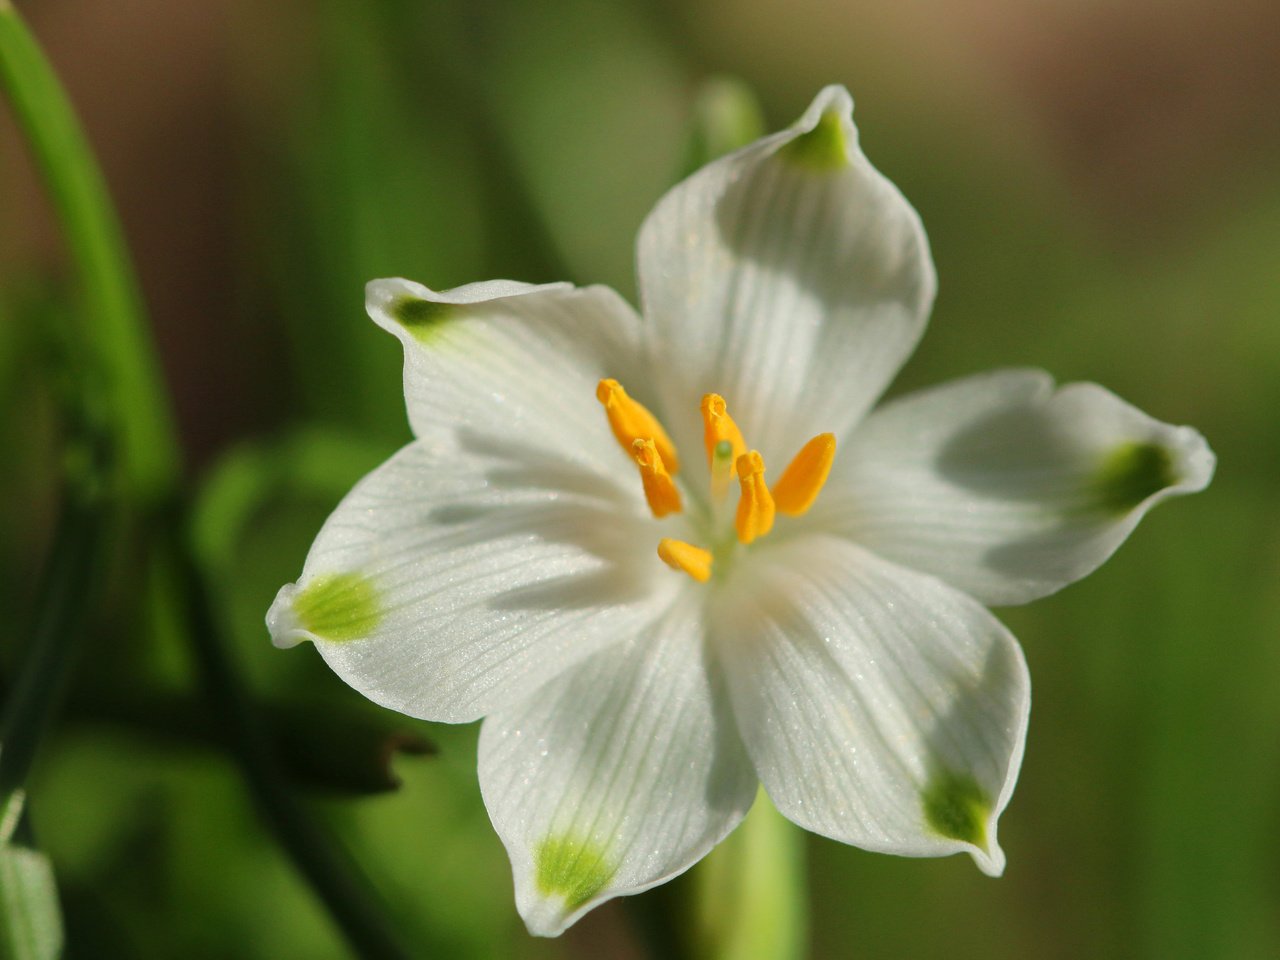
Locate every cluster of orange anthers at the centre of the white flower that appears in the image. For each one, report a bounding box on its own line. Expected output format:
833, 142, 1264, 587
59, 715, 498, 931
595, 379, 836, 582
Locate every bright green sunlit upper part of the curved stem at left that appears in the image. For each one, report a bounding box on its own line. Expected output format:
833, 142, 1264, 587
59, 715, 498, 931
0, 0, 179, 502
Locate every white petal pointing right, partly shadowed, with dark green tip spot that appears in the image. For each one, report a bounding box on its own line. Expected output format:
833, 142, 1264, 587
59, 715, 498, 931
806, 370, 1213, 604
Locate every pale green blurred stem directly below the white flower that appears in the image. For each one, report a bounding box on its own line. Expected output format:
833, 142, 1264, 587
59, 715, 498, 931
692, 790, 808, 960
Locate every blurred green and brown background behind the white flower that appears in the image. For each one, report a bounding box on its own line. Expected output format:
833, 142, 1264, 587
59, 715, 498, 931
0, 0, 1280, 960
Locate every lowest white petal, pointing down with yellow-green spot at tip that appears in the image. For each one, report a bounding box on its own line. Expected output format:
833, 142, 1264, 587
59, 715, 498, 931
480, 595, 756, 936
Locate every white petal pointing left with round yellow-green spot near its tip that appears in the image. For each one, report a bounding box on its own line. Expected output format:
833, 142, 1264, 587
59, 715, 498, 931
268, 433, 680, 722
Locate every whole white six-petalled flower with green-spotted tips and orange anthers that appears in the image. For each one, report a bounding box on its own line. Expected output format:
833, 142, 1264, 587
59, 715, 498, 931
268, 87, 1213, 934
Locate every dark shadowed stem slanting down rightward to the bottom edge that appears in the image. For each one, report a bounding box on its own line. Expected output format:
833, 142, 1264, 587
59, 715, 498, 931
169, 522, 413, 960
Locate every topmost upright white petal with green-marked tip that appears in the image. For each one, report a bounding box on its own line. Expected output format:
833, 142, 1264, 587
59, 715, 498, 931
639, 87, 936, 468
